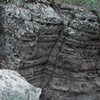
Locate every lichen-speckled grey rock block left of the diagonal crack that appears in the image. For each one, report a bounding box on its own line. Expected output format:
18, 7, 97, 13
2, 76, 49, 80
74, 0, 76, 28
2, 3, 63, 86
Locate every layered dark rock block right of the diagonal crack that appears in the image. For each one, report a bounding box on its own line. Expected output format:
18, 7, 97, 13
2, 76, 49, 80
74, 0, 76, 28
45, 4, 100, 100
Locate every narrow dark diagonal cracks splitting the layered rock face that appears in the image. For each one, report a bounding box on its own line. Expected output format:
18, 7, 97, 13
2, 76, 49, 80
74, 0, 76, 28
40, 25, 63, 90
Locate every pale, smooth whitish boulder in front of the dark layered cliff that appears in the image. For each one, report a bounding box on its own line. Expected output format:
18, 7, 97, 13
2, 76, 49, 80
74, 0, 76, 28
0, 70, 41, 100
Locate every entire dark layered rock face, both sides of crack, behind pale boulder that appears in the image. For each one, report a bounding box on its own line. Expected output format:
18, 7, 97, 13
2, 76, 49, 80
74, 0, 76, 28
2, 3, 100, 100
